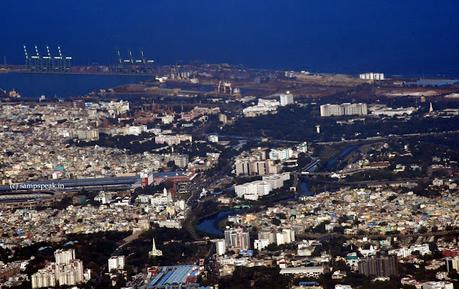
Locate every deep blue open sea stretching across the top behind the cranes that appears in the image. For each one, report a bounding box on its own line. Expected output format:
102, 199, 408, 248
0, 0, 459, 75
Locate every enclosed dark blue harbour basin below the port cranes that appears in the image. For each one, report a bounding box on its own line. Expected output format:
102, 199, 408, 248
0, 73, 151, 98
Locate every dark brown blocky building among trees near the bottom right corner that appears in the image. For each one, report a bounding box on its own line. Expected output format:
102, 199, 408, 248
359, 256, 398, 277
